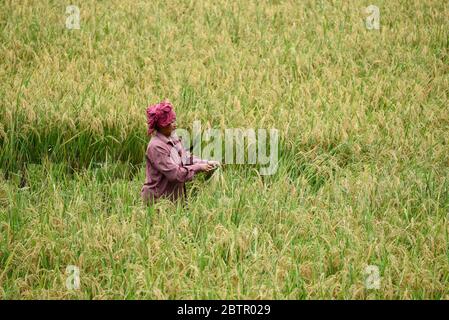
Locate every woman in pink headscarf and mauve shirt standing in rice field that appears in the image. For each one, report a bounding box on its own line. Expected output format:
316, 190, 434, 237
141, 101, 219, 203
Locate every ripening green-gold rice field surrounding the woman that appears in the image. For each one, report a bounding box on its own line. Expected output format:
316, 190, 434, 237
0, 0, 449, 299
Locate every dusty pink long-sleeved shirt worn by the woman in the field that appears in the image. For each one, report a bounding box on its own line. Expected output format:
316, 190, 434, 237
141, 132, 207, 202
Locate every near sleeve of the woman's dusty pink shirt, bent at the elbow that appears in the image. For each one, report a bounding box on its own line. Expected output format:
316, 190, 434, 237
147, 144, 201, 182
